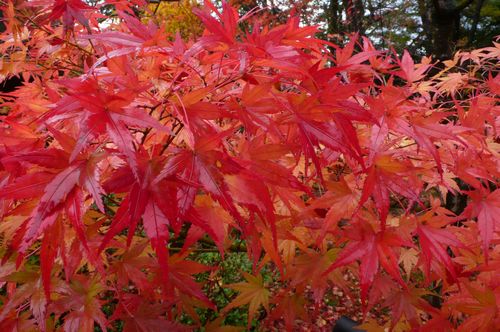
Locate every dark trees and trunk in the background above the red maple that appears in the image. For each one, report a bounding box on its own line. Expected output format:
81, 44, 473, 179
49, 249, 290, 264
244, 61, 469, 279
232, 0, 500, 60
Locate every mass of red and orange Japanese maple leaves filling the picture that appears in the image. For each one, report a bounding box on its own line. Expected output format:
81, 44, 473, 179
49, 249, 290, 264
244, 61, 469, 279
0, 0, 500, 331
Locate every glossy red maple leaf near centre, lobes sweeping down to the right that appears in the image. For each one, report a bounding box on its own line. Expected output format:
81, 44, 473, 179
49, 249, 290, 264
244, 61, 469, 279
155, 131, 280, 265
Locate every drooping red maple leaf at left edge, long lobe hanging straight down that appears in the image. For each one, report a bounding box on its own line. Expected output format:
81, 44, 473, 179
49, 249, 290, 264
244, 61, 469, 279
0, 137, 109, 298
